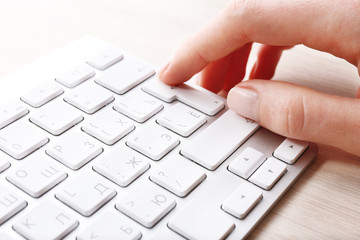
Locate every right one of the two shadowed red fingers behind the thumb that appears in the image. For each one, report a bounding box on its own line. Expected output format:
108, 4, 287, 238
249, 45, 291, 79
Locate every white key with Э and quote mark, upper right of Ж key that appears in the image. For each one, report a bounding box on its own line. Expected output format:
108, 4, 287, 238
126, 125, 180, 160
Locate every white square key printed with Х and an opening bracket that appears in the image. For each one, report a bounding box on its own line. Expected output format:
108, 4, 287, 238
82, 108, 135, 145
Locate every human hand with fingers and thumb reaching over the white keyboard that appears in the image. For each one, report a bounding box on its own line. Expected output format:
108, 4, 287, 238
159, 0, 360, 155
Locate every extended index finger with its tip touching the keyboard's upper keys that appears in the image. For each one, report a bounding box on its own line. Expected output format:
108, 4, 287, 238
159, 0, 360, 85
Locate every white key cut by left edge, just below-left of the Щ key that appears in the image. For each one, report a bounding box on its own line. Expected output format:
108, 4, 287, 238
0, 185, 27, 225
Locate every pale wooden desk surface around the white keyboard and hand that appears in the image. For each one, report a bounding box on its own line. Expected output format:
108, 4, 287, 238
0, 0, 360, 239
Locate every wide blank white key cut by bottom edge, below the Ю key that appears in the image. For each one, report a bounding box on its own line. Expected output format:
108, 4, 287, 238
168, 200, 235, 240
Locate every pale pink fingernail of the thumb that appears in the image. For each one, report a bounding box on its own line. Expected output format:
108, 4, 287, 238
227, 87, 259, 121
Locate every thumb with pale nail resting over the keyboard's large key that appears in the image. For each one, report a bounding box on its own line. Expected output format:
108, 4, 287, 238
228, 80, 360, 156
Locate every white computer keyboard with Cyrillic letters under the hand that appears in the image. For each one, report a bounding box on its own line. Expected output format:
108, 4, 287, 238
0, 37, 317, 240
